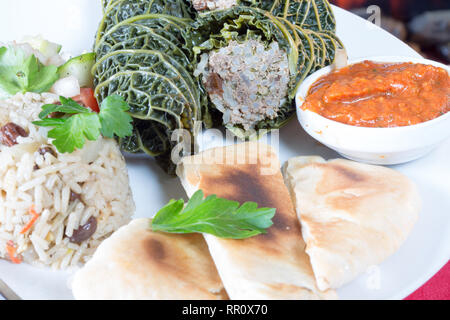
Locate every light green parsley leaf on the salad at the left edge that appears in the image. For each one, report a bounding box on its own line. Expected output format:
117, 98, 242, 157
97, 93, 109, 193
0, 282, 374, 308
0, 47, 59, 99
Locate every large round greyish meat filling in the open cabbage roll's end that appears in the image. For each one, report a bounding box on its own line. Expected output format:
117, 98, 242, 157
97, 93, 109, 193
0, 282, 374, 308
196, 40, 289, 130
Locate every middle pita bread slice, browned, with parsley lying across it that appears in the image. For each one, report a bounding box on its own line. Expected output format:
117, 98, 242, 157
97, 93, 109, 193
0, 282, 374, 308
177, 142, 337, 300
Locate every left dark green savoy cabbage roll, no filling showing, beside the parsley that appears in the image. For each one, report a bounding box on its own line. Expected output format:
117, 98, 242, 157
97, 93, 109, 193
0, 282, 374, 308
92, 0, 210, 173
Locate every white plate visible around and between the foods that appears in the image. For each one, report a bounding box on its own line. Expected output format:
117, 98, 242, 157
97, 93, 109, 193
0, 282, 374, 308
0, 0, 450, 299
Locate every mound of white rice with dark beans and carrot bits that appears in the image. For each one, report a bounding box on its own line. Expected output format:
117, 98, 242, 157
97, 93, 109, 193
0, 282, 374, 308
0, 93, 135, 269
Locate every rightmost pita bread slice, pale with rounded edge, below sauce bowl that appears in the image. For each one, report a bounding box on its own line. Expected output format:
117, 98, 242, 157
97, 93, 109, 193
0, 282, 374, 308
283, 157, 421, 290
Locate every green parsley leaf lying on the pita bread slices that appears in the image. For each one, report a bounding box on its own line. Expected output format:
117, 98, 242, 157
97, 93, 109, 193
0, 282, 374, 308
151, 190, 276, 239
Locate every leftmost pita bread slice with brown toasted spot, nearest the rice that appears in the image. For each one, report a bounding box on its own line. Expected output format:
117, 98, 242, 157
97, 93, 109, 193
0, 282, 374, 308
72, 219, 227, 300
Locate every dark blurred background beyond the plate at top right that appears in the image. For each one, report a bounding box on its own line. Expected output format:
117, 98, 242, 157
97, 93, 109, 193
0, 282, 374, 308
330, 0, 450, 64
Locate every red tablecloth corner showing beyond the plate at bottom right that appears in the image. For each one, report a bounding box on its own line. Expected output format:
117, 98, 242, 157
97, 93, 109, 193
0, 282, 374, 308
405, 262, 450, 300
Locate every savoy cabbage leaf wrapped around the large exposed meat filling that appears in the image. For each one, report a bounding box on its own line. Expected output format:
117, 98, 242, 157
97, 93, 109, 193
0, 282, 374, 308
190, 6, 341, 139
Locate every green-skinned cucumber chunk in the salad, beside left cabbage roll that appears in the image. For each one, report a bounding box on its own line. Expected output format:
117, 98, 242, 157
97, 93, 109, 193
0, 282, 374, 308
58, 52, 95, 88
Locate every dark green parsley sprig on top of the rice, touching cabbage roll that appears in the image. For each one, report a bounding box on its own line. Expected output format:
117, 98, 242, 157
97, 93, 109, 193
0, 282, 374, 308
33, 95, 133, 153
